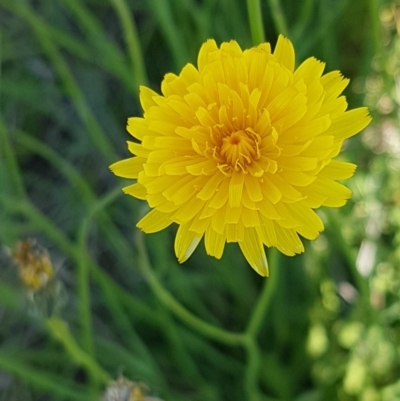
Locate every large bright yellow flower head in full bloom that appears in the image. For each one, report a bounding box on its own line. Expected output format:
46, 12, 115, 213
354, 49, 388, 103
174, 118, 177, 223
110, 36, 371, 276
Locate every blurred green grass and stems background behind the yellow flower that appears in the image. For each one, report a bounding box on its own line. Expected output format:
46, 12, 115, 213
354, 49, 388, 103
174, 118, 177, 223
0, 0, 400, 401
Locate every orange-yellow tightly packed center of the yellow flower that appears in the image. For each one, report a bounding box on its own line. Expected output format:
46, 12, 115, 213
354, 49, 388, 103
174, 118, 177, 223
220, 128, 261, 171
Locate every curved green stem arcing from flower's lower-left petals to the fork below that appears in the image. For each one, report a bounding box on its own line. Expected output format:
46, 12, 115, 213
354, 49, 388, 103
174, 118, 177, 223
136, 233, 245, 345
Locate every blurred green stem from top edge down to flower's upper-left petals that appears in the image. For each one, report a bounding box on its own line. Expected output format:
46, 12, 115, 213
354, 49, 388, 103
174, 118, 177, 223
111, 0, 148, 86
